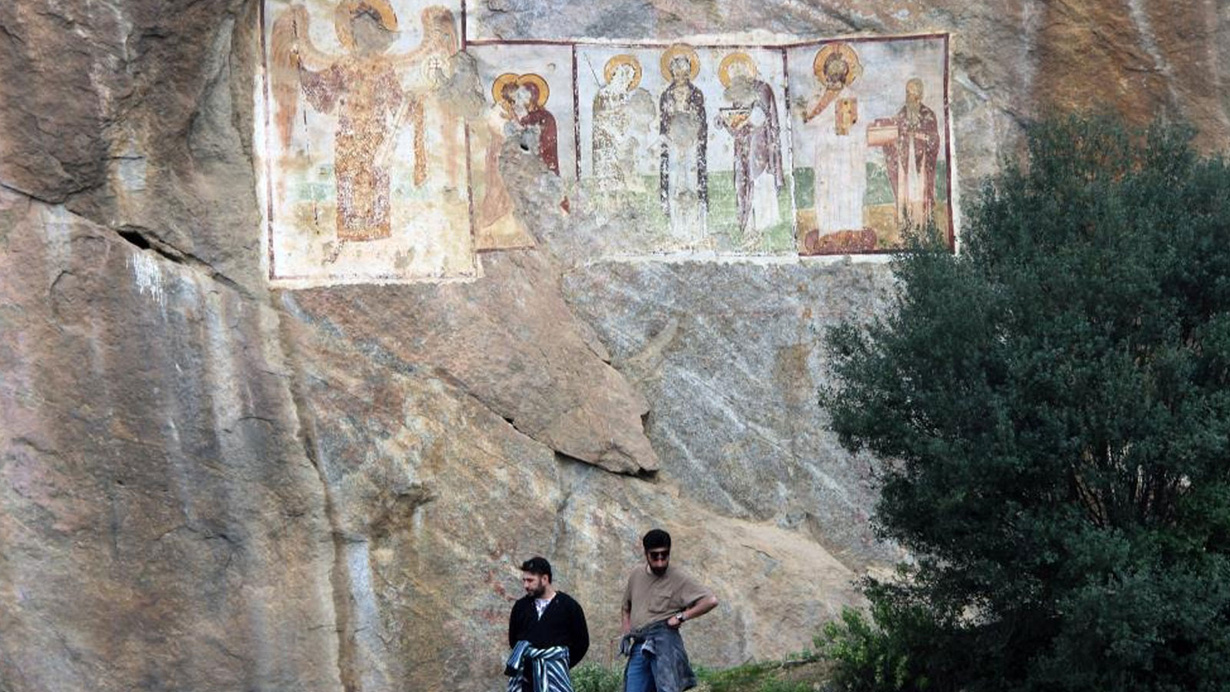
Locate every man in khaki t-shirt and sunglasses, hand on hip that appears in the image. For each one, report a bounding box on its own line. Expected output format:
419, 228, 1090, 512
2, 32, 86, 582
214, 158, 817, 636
621, 529, 717, 692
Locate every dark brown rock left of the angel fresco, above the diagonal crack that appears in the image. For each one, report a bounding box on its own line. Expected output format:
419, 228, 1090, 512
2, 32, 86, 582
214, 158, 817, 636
0, 0, 263, 293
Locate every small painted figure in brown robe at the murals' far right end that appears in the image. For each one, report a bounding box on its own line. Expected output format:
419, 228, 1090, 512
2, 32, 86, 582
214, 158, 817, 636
875, 77, 940, 227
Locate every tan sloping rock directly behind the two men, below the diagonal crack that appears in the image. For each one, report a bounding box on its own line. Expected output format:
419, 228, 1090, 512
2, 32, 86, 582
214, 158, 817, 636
287, 309, 856, 690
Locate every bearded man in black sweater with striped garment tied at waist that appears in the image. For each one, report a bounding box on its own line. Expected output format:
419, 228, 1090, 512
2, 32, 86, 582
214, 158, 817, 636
504, 557, 589, 692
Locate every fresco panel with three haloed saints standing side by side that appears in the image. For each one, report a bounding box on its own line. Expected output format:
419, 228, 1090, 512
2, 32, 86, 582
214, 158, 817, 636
577, 43, 795, 254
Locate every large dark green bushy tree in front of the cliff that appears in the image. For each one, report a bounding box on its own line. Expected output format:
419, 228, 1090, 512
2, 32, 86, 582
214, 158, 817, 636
822, 118, 1230, 692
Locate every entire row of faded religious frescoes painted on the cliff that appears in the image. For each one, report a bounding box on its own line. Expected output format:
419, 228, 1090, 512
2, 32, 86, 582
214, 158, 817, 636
257, 0, 953, 286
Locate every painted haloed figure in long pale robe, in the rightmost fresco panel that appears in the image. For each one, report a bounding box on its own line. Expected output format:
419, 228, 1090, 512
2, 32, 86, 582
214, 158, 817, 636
803, 43, 867, 237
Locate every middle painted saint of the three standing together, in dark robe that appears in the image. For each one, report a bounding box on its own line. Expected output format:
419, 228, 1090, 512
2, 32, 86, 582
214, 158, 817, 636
658, 43, 708, 246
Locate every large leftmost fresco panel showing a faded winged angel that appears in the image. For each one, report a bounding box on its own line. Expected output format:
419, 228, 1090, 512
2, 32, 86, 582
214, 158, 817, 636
258, 0, 478, 286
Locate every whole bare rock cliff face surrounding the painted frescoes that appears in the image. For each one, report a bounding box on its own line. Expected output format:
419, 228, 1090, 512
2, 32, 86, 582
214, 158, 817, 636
0, 0, 1230, 692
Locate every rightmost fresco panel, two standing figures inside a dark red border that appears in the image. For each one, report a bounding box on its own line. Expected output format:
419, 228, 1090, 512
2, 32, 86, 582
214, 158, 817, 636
786, 34, 952, 254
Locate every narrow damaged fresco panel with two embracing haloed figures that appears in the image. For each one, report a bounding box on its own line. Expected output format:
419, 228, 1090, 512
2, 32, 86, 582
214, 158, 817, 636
469, 43, 577, 251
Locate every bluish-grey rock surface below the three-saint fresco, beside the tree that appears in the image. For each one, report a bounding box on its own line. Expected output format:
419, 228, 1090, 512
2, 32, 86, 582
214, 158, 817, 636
565, 256, 895, 570
